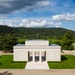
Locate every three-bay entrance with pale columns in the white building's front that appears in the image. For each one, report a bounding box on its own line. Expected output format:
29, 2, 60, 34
28, 51, 46, 62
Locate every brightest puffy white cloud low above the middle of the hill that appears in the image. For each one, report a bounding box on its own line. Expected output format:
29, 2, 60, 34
20, 19, 61, 27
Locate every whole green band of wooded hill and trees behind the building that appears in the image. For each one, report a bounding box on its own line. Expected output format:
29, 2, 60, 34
0, 26, 75, 51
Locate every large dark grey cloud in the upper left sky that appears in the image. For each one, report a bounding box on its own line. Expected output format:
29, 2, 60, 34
0, 0, 50, 14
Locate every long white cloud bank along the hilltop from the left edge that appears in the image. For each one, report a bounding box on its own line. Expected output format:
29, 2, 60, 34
0, 18, 62, 28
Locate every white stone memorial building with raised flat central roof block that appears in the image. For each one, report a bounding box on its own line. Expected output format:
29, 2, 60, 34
13, 40, 61, 62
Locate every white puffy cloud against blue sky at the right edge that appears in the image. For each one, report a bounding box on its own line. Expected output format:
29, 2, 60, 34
52, 13, 75, 21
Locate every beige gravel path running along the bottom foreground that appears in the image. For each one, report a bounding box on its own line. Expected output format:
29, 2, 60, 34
0, 69, 75, 75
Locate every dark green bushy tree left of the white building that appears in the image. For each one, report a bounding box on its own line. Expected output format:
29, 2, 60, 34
0, 34, 17, 50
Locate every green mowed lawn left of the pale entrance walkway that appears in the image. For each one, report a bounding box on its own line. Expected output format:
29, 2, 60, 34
0, 55, 26, 69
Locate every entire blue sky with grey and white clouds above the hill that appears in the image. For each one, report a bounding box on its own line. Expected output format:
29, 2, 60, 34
0, 0, 75, 31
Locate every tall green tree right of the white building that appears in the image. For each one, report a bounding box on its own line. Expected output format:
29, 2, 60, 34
62, 31, 73, 50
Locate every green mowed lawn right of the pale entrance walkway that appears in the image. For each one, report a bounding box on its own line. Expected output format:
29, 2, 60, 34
48, 55, 75, 69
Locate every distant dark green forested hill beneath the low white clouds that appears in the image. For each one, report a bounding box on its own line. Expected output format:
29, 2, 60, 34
0, 25, 75, 39
